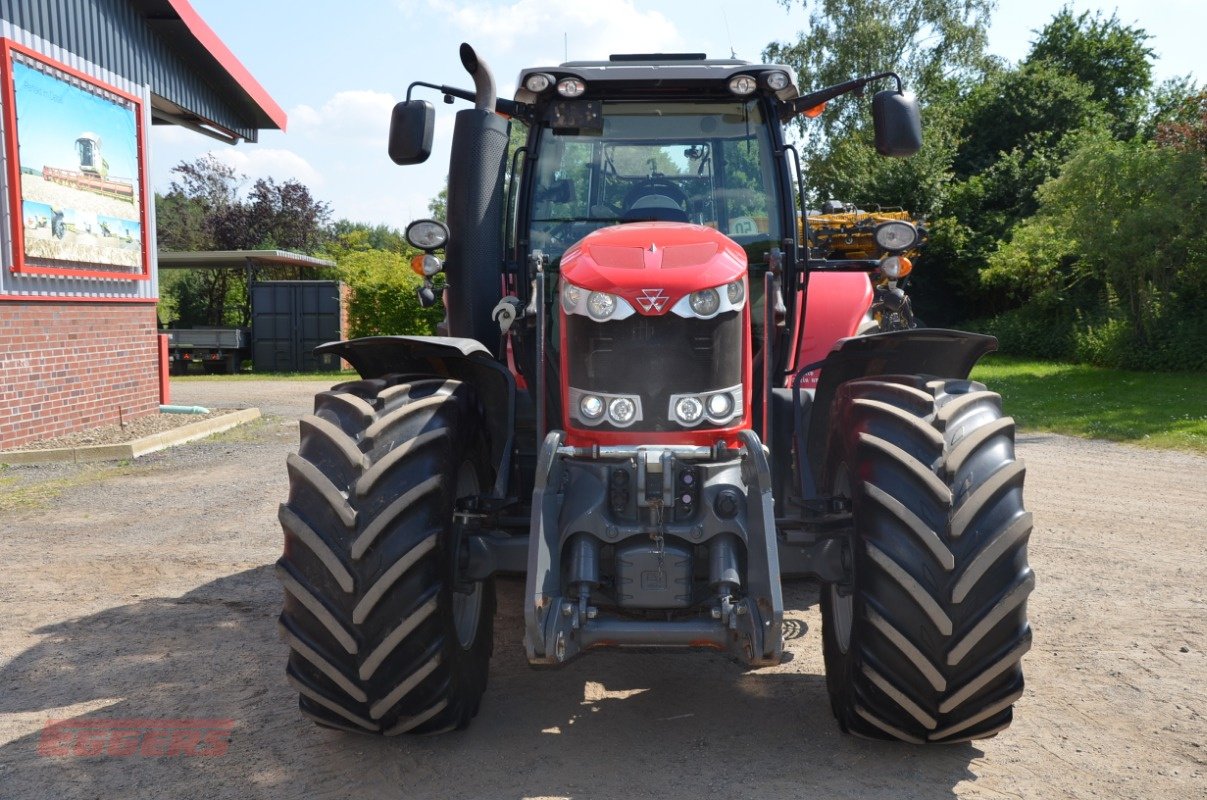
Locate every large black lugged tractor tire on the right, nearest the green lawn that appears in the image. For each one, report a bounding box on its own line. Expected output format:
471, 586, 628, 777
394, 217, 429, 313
821, 376, 1034, 743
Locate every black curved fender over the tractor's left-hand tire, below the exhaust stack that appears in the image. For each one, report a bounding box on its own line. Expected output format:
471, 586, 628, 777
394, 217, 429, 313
315, 337, 515, 500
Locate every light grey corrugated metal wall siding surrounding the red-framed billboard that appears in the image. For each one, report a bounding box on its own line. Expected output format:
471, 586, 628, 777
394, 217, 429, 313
0, 18, 159, 300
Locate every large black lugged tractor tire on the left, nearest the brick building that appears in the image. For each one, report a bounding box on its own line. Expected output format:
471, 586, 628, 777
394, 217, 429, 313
276, 375, 495, 735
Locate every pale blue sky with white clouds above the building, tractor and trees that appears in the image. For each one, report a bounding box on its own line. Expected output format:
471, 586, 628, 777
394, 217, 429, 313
151, 0, 1207, 228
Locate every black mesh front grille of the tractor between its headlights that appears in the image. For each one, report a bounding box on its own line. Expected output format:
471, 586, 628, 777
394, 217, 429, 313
564, 311, 742, 431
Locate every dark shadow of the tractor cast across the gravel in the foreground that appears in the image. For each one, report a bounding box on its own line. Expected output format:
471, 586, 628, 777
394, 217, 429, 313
0, 567, 984, 800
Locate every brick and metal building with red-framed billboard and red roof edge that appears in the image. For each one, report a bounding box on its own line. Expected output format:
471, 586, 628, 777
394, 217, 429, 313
0, 0, 285, 448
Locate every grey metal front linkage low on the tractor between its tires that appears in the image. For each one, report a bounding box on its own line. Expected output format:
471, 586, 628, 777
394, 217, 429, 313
524, 431, 783, 666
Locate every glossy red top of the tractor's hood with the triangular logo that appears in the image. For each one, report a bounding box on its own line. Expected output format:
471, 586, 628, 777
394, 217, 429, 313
561, 222, 746, 316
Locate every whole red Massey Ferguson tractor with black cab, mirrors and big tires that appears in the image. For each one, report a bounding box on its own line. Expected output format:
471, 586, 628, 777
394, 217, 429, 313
278, 45, 1034, 742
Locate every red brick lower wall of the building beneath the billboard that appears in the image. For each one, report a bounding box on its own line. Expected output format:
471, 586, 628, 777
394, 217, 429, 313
0, 302, 159, 451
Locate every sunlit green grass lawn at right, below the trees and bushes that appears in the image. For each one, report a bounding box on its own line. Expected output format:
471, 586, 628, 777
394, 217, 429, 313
973, 356, 1207, 454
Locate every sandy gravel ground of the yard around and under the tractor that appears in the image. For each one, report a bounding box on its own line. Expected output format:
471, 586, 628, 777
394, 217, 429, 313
0, 381, 1207, 800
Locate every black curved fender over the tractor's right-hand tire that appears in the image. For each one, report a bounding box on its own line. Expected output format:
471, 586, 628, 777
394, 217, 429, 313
793, 328, 997, 500
